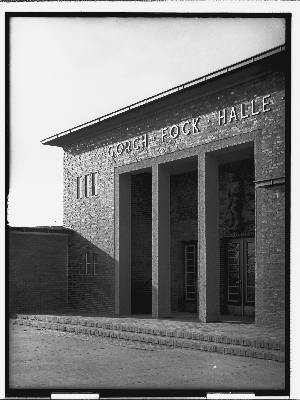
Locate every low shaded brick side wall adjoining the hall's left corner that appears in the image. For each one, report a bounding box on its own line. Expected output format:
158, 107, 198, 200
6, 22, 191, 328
9, 232, 68, 313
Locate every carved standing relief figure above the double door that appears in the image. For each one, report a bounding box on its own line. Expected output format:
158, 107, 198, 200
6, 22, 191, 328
221, 172, 243, 231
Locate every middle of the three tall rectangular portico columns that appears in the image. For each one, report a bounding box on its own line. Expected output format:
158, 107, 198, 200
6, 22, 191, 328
152, 165, 171, 318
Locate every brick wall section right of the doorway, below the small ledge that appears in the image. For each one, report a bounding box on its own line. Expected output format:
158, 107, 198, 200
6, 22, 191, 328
255, 189, 285, 327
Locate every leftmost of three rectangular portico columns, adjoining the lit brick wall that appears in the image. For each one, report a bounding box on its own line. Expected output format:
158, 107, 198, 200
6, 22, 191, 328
115, 174, 131, 315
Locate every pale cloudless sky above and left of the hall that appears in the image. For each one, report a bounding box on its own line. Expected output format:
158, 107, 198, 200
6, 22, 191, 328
8, 16, 285, 226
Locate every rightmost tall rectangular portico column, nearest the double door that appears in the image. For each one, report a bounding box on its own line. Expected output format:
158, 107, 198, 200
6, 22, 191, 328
198, 152, 220, 322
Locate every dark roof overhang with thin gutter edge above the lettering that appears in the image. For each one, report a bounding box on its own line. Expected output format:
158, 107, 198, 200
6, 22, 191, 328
42, 46, 285, 147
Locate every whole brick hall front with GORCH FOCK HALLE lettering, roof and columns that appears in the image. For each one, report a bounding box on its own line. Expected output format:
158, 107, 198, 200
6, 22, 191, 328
43, 46, 290, 326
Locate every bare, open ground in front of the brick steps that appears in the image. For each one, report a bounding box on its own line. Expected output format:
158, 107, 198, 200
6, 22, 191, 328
9, 324, 285, 391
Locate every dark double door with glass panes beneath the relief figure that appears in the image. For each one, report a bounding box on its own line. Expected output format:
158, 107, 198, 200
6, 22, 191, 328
226, 238, 255, 316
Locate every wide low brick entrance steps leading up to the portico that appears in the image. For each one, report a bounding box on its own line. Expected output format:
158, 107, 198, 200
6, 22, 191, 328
12, 312, 285, 362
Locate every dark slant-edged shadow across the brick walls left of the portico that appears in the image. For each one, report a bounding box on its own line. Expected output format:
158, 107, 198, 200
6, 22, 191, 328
8, 231, 115, 315
